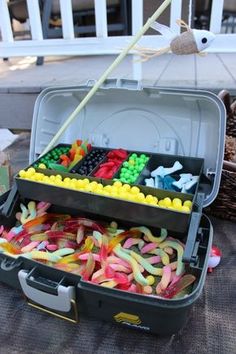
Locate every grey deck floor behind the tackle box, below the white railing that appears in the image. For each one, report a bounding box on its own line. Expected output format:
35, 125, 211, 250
0, 54, 236, 129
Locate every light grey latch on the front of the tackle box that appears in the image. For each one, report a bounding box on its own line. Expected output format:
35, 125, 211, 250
18, 269, 75, 312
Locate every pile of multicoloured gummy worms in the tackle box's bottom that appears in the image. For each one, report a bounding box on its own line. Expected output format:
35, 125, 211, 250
0, 201, 196, 299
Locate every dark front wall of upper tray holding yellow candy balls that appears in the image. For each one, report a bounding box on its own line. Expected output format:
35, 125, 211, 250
16, 171, 195, 232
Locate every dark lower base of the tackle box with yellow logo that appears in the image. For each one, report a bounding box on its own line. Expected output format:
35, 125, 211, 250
0, 194, 212, 335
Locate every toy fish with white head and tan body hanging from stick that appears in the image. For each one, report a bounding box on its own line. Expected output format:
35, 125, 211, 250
135, 20, 215, 61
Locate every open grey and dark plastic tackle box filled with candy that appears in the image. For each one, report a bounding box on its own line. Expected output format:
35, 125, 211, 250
0, 79, 226, 334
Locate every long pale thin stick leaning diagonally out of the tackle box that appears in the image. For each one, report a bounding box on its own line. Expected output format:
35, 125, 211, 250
41, 0, 171, 156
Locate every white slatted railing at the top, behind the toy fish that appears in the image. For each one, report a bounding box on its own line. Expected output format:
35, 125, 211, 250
0, 0, 236, 57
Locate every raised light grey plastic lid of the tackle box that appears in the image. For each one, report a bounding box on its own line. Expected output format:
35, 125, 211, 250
30, 79, 226, 207
